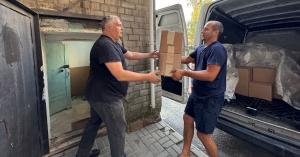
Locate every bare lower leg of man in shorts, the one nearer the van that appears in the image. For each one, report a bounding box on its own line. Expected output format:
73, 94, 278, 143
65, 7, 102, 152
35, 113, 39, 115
197, 132, 218, 157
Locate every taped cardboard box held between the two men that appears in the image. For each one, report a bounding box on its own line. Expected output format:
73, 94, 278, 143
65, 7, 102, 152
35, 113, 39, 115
159, 31, 183, 76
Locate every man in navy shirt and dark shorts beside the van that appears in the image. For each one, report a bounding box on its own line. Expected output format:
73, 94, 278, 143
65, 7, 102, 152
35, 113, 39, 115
172, 21, 227, 157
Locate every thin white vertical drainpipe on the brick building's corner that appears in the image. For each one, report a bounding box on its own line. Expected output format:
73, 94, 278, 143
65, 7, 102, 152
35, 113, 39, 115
149, 0, 155, 108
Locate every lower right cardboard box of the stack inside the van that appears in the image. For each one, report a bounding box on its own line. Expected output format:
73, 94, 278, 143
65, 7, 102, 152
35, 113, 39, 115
249, 82, 273, 101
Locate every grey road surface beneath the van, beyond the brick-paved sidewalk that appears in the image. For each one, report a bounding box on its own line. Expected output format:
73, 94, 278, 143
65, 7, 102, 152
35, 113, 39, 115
161, 97, 276, 157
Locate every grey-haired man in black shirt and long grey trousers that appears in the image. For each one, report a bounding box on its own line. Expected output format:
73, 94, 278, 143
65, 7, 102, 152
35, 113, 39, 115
76, 16, 160, 157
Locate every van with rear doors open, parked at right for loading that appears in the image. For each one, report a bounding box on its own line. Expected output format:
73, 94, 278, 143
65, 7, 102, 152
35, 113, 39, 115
156, 0, 300, 157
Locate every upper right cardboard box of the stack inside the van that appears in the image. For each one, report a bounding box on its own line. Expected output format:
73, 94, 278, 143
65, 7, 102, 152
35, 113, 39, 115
252, 67, 276, 83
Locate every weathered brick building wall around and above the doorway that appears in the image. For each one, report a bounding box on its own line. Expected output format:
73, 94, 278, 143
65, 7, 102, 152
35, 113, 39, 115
19, 0, 162, 130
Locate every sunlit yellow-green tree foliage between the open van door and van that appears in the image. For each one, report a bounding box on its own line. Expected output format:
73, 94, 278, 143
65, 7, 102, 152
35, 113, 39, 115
187, 0, 212, 46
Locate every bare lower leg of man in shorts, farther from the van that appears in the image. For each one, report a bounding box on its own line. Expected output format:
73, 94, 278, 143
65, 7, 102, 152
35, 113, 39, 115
180, 113, 194, 157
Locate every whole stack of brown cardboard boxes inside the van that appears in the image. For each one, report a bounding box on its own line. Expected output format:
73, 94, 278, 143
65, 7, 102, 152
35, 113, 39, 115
236, 67, 276, 101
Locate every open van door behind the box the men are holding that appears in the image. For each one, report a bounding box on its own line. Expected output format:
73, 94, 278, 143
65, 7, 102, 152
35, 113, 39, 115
155, 4, 188, 103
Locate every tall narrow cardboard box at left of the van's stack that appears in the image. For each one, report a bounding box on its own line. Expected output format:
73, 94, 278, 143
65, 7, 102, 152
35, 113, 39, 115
235, 67, 252, 96
